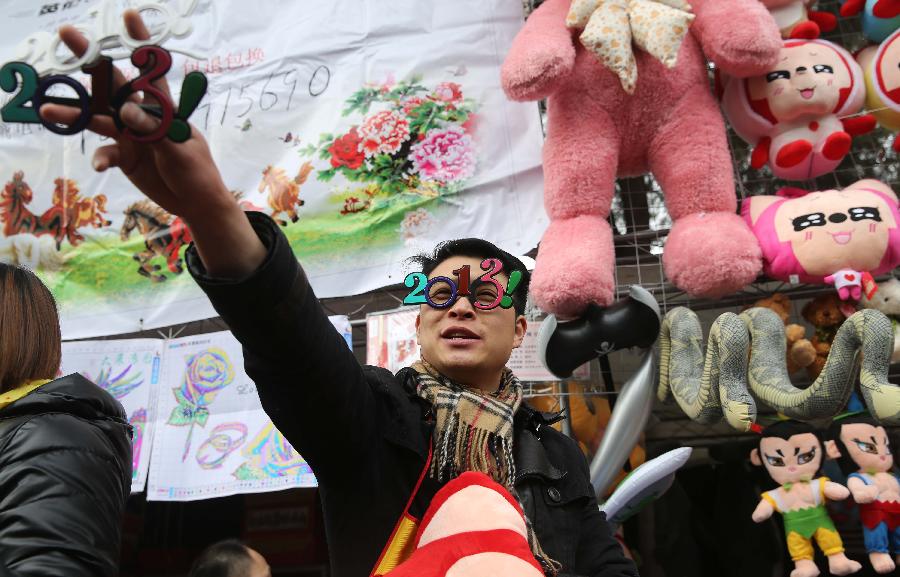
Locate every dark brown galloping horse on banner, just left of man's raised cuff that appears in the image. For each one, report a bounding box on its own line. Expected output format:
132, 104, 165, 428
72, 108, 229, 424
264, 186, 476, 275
120, 200, 191, 282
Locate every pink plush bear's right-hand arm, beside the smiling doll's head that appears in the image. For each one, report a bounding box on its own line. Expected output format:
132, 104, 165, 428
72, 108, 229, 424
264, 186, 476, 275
691, 0, 782, 78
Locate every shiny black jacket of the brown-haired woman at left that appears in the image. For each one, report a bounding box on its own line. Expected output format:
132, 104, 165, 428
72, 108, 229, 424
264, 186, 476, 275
0, 374, 131, 577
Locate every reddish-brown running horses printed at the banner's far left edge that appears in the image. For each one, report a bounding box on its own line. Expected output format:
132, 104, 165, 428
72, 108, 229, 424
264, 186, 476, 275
0, 170, 111, 250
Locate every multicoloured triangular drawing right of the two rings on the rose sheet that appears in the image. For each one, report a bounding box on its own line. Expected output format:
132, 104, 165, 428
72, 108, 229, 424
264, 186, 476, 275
232, 422, 312, 481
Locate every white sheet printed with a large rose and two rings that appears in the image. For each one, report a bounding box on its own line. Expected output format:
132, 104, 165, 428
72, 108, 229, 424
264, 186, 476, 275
147, 331, 316, 501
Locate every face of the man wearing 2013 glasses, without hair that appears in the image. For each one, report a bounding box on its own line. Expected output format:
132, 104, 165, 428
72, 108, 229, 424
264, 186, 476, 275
416, 256, 527, 388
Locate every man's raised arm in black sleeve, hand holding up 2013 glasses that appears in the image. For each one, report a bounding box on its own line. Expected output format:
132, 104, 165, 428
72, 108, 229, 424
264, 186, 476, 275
40, 10, 376, 478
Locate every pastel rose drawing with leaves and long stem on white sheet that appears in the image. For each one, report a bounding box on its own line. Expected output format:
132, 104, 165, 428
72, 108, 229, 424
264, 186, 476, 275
167, 347, 234, 462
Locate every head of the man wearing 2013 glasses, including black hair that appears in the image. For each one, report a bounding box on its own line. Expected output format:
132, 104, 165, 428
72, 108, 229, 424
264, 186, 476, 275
411, 238, 530, 390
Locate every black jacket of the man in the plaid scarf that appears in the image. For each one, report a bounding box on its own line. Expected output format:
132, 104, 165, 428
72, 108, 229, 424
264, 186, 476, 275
186, 213, 637, 577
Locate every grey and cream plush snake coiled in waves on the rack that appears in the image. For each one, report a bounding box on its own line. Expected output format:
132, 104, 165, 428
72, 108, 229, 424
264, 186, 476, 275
657, 307, 900, 431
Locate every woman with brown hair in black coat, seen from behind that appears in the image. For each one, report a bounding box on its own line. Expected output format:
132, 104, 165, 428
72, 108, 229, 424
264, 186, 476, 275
0, 264, 131, 577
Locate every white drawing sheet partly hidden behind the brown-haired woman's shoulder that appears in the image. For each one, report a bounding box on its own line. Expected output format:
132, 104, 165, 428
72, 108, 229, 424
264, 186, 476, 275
60, 339, 163, 493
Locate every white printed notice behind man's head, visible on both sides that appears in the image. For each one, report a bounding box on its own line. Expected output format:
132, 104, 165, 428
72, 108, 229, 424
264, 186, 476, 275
366, 307, 590, 381
